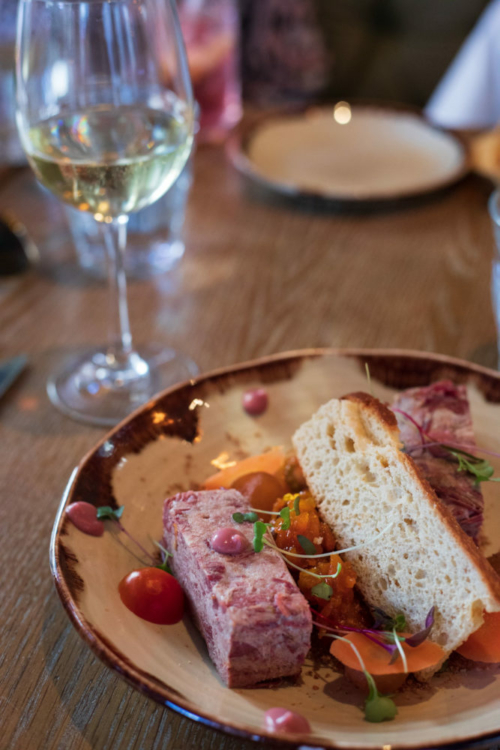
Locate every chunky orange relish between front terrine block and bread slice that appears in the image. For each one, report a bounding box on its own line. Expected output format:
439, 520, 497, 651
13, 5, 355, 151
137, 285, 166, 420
273, 491, 368, 627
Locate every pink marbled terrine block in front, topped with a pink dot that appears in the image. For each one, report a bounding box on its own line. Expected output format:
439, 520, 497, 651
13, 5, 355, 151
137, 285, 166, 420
163, 490, 312, 688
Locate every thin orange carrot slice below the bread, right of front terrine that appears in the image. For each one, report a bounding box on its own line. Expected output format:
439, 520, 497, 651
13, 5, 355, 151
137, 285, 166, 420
330, 633, 445, 675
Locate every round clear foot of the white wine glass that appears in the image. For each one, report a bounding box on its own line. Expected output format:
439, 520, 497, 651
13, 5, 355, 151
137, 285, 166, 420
47, 344, 199, 427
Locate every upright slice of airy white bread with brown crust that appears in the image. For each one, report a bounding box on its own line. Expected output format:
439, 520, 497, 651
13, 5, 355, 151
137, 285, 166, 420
293, 393, 500, 677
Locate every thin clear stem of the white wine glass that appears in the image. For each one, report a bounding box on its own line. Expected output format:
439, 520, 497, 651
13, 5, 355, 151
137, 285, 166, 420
102, 216, 132, 366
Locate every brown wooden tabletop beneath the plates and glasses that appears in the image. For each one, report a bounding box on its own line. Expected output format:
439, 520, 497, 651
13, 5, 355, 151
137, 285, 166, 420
0, 148, 495, 750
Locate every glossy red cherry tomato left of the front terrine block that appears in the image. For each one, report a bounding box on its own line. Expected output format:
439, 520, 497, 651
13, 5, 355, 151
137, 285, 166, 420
118, 568, 184, 625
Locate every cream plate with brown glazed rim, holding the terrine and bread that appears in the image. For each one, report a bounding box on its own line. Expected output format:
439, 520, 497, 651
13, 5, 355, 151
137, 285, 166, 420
51, 350, 500, 750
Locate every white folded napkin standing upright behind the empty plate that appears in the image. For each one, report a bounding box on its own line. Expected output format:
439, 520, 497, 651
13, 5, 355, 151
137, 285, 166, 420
425, 0, 500, 129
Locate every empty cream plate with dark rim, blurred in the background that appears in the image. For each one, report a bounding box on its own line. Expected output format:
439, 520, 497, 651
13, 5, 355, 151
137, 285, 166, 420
232, 102, 466, 203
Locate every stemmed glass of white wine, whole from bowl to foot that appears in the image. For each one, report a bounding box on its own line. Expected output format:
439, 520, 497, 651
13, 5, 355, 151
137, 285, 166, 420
16, 0, 197, 425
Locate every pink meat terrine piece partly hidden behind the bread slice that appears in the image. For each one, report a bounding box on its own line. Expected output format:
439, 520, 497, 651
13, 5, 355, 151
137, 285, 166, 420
393, 380, 484, 542
